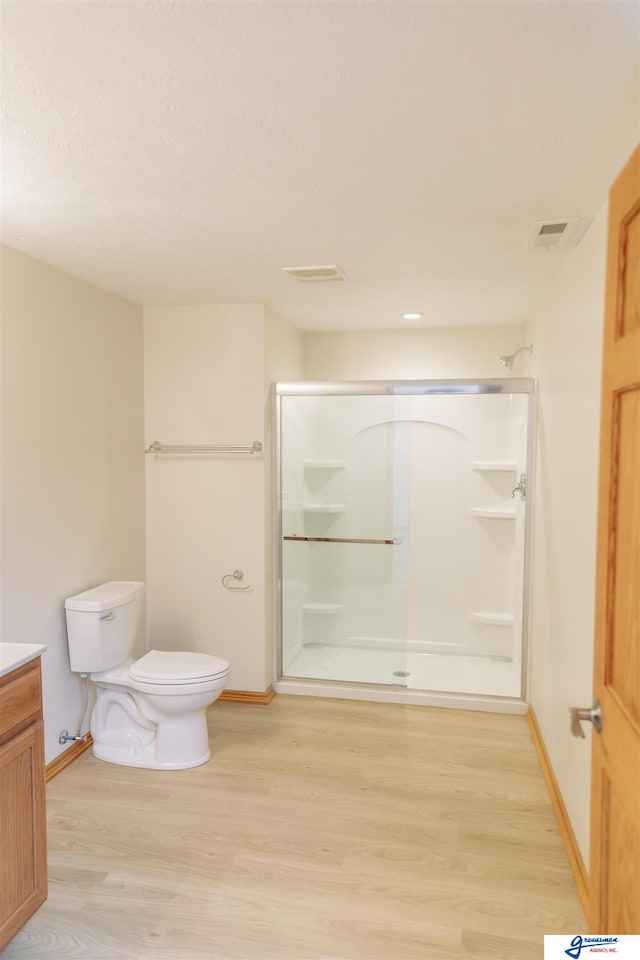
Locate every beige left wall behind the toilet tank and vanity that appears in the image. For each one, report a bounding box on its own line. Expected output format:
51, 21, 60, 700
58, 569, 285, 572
1, 247, 144, 761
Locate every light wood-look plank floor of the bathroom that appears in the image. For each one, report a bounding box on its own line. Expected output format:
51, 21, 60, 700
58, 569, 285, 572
3, 695, 586, 960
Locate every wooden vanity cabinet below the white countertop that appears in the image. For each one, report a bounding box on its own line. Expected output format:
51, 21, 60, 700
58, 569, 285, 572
0, 657, 47, 951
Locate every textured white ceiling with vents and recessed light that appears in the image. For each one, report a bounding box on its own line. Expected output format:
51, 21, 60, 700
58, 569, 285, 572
1, 0, 640, 330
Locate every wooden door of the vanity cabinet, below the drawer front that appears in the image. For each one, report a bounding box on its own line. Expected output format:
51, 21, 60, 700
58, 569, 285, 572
0, 722, 47, 950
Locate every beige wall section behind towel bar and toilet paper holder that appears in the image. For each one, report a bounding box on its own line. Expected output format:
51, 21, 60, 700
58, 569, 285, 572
144, 304, 271, 690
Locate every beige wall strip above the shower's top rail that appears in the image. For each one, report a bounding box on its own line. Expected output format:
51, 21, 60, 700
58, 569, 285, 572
304, 325, 529, 380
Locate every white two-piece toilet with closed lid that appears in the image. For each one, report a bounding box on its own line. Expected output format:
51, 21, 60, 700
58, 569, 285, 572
64, 580, 229, 770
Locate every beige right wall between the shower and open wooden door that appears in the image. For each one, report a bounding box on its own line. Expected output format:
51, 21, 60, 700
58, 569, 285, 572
528, 209, 607, 868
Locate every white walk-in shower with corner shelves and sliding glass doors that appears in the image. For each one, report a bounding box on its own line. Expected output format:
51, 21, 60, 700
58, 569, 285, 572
275, 379, 533, 706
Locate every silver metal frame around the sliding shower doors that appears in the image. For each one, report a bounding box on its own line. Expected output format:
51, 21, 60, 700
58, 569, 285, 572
273, 377, 536, 712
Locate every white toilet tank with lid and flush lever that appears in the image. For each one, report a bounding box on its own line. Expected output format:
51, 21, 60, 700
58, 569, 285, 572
64, 580, 144, 673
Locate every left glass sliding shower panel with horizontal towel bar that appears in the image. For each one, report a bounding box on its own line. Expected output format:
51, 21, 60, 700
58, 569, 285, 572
279, 396, 411, 686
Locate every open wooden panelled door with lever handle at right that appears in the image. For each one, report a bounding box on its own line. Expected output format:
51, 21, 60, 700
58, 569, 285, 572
592, 147, 640, 934
